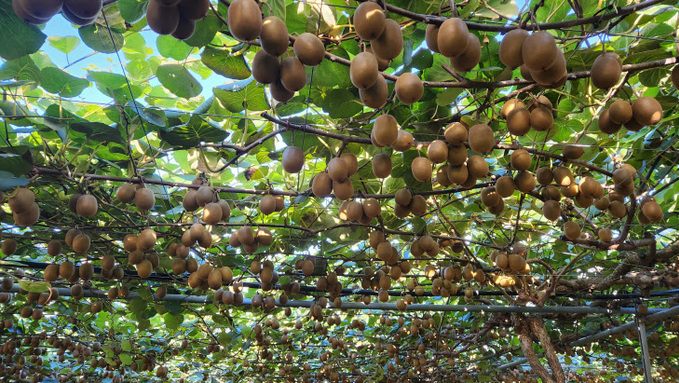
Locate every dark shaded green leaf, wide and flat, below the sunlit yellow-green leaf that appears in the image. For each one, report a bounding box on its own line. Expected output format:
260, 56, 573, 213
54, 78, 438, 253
160, 115, 228, 148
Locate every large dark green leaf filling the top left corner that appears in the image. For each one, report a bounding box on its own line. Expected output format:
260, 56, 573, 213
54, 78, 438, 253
0, 0, 47, 60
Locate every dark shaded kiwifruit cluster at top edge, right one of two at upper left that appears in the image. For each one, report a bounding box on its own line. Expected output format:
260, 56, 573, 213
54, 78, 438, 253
147, 0, 211, 40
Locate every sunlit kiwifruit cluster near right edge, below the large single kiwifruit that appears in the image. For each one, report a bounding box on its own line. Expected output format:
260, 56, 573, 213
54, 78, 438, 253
597, 96, 663, 134
